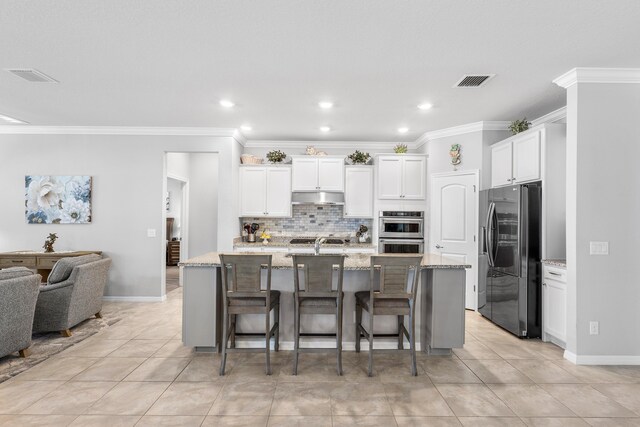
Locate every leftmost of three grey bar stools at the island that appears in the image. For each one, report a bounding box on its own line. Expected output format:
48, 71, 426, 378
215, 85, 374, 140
220, 254, 280, 375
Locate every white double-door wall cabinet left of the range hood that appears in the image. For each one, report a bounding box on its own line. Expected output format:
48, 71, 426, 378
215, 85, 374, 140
240, 166, 291, 217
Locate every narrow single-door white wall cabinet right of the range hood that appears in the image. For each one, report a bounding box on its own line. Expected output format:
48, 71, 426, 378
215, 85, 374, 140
344, 166, 373, 218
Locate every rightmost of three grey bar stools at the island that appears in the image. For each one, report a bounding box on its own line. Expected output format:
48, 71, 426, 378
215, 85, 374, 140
355, 255, 422, 376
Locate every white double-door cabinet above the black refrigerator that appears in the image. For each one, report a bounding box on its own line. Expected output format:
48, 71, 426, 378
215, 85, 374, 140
491, 129, 543, 187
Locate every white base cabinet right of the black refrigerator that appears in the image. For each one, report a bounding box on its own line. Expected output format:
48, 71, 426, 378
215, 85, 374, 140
542, 265, 567, 347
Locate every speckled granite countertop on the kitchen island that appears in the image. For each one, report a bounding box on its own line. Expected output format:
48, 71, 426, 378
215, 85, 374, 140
178, 252, 471, 270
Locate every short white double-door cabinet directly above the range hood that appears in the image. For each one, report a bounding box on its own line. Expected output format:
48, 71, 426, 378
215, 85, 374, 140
292, 156, 344, 191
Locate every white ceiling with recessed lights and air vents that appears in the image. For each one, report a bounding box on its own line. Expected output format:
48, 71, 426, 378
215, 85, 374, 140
0, 0, 640, 141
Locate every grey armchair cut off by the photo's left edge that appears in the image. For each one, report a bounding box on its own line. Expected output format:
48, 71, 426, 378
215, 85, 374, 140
0, 267, 42, 357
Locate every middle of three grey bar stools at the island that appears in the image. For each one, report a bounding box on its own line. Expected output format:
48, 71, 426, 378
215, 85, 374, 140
292, 255, 345, 375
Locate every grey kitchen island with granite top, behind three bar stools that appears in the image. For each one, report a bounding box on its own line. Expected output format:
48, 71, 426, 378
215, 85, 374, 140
179, 252, 470, 354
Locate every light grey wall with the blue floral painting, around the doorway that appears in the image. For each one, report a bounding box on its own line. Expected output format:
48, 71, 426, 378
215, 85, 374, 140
0, 134, 242, 298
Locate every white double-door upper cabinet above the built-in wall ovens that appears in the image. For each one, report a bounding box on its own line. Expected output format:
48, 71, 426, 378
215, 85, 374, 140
377, 155, 426, 200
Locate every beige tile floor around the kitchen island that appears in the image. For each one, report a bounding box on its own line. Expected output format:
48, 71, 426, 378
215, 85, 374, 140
0, 289, 640, 427
